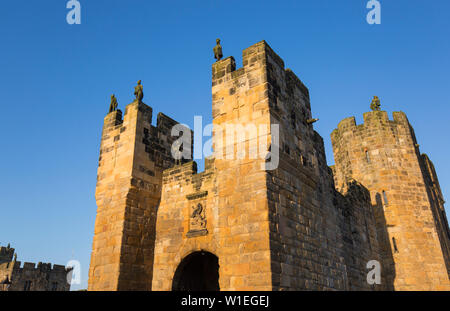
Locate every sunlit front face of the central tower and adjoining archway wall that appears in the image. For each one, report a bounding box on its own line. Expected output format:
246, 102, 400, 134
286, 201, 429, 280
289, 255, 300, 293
153, 42, 272, 290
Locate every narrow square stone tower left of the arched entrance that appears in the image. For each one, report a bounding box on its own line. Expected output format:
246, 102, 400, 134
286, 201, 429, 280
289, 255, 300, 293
88, 100, 191, 290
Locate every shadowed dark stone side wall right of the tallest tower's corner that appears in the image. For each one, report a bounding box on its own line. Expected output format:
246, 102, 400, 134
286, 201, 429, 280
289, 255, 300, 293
266, 42, 378, 290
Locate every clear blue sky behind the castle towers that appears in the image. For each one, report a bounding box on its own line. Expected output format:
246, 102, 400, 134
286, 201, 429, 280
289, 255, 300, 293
0, 0, 450, 289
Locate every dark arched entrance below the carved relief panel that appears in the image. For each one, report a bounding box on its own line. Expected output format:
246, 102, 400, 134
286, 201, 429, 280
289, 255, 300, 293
172, 251, 220, 291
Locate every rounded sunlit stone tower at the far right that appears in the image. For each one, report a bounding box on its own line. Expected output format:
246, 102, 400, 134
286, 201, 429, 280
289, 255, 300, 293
331, 111, 450, 290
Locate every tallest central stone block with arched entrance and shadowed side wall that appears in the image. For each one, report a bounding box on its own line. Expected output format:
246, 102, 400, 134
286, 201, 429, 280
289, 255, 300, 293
153, 41, 379, 290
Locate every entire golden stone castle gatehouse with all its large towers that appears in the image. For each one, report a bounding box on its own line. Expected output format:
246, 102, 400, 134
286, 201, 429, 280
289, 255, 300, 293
89, 41, 450, 290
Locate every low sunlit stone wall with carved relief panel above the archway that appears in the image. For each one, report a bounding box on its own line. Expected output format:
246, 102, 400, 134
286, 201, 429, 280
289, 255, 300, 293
153, 162, 222, 290
